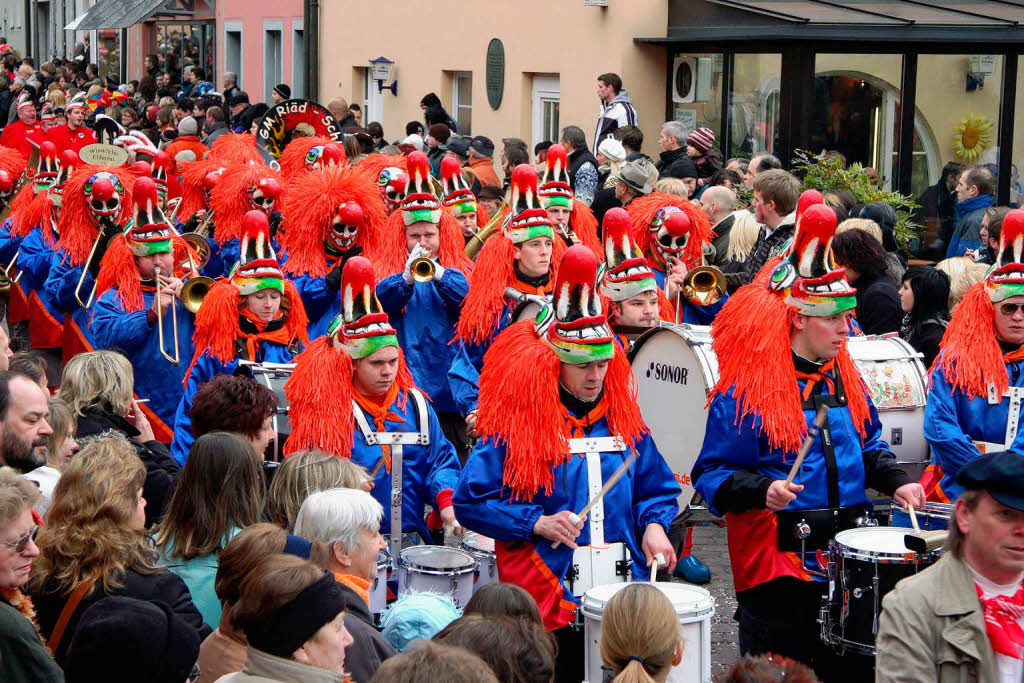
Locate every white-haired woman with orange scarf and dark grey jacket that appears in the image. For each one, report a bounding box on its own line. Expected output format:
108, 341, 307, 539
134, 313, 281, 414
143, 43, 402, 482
295, 488, 395, 681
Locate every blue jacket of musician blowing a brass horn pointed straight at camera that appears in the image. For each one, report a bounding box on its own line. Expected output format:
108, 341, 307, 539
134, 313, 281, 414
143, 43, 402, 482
378, 268, 469, 413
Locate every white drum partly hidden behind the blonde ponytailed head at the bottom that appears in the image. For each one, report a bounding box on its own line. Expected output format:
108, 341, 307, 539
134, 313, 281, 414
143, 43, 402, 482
581, 583, 715, 683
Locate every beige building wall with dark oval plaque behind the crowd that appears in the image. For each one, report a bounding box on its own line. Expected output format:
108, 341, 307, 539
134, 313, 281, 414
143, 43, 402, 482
319, 0, 668, 156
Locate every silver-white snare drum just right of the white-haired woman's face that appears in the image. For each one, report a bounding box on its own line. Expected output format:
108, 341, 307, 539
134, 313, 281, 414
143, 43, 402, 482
398, 546, 476, 609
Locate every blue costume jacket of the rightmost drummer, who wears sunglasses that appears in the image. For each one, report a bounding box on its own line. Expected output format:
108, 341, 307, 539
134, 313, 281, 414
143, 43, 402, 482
925, 360, 1024, 503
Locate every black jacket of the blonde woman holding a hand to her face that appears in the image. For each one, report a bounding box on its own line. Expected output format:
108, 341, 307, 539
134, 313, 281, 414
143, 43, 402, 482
75, 408, 181, 528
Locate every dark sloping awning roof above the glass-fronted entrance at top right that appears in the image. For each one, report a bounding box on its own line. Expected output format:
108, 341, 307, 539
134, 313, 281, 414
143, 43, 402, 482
636, 0, 1024, 45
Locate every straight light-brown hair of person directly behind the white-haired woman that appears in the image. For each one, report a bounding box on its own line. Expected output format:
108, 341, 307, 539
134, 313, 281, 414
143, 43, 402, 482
267, 451, 370, 531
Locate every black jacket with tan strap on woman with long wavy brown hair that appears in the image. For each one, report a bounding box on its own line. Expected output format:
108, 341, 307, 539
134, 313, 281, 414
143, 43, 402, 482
32, 570, 211, 667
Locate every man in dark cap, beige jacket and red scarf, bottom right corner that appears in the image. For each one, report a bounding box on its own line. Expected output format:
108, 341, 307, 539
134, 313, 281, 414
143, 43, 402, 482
876, 452, 1024, 682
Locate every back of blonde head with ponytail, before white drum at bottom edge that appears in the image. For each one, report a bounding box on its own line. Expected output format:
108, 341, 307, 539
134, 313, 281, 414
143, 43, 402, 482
601, 584, 683, 683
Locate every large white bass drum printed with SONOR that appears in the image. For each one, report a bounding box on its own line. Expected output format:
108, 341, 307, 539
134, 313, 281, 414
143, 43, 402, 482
630, 323, 718, 505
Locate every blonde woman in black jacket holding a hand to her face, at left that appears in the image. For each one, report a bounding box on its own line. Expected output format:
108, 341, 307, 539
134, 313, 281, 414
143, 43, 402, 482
60, 350, 179, 526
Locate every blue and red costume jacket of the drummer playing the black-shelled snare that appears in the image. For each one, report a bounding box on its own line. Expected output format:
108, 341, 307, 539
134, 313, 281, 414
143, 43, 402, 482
691, 362, 909, 592
